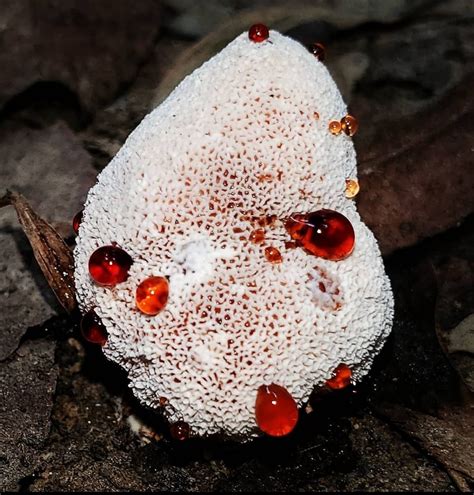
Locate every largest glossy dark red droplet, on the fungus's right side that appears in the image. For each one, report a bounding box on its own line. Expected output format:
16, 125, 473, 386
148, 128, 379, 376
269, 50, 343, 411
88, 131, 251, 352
285, 210, 355, 261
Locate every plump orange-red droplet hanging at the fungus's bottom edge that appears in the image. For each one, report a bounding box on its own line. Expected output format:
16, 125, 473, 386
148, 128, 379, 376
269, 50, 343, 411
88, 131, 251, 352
255, 383, 298, 437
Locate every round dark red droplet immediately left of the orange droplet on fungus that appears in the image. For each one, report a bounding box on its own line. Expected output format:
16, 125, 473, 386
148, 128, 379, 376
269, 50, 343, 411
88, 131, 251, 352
89, 245, 133, 287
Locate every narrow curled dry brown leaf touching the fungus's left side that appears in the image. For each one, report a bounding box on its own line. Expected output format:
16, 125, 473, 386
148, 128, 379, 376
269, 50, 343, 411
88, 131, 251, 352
0, 190, 77, 313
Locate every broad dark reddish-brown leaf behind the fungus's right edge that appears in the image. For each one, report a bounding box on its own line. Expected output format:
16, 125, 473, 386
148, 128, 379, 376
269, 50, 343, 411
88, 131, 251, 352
356, 74, 474, 255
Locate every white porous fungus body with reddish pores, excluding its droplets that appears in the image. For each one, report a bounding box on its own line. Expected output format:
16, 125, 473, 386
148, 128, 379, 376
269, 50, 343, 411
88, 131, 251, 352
75, 31, 393, 440
